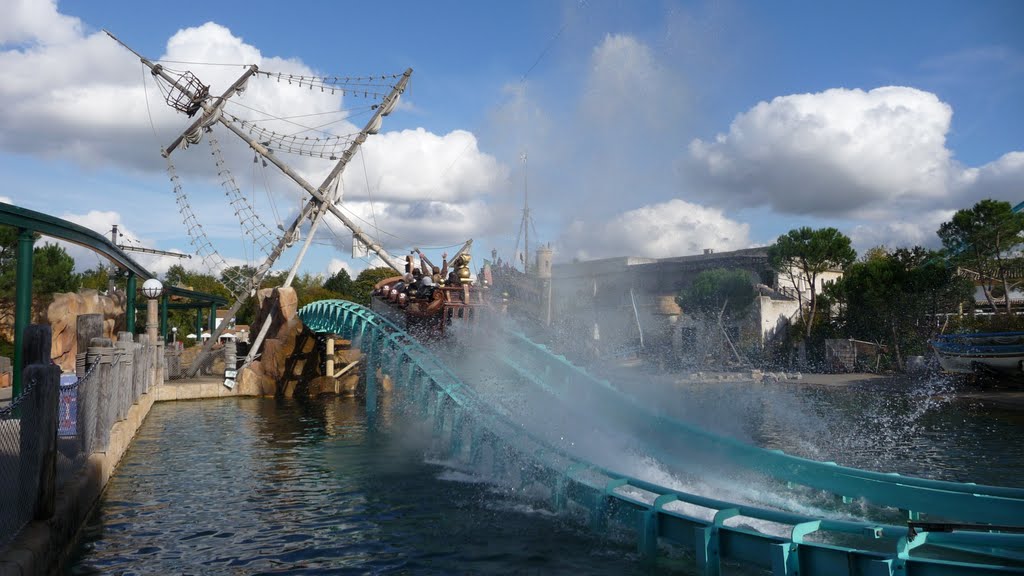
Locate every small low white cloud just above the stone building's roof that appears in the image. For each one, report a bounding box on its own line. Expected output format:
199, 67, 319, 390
557, 199, 751, 259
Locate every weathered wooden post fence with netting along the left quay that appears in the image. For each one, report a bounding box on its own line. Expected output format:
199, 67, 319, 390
0, 315, 162, 549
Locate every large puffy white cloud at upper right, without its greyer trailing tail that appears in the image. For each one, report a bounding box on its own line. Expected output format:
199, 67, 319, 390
681, 86, 953, 216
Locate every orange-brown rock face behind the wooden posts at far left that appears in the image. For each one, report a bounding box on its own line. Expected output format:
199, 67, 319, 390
46, 290, 127, 372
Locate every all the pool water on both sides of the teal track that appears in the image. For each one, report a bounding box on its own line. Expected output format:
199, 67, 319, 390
72, 358, 1024, 574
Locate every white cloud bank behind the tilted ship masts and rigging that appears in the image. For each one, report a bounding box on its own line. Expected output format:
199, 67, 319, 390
0, 0, 507, 270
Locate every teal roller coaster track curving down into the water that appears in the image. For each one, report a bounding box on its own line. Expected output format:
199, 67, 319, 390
299, 300, 1024, 576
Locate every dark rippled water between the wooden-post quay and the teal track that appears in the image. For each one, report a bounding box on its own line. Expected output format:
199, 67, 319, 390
71, 398, 690, 575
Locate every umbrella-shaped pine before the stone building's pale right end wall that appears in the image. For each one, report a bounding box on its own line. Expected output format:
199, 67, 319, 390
768, 227, 857, 336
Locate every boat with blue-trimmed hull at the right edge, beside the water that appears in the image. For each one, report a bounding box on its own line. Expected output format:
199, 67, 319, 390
931, 332, 1024, 376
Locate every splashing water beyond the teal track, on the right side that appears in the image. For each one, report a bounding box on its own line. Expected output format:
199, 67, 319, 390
610, 368, 1024, 488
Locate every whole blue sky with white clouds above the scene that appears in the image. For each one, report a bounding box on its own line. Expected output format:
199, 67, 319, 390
0, 0, 1024, 277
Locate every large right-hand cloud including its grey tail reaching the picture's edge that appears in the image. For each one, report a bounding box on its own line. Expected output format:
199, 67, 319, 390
678, 86, 1024, 249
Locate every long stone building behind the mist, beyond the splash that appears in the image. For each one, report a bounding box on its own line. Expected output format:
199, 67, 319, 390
497, 247, 842, 358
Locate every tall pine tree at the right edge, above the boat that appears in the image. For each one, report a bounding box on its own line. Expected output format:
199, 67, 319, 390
938, 200, 1024, 316
